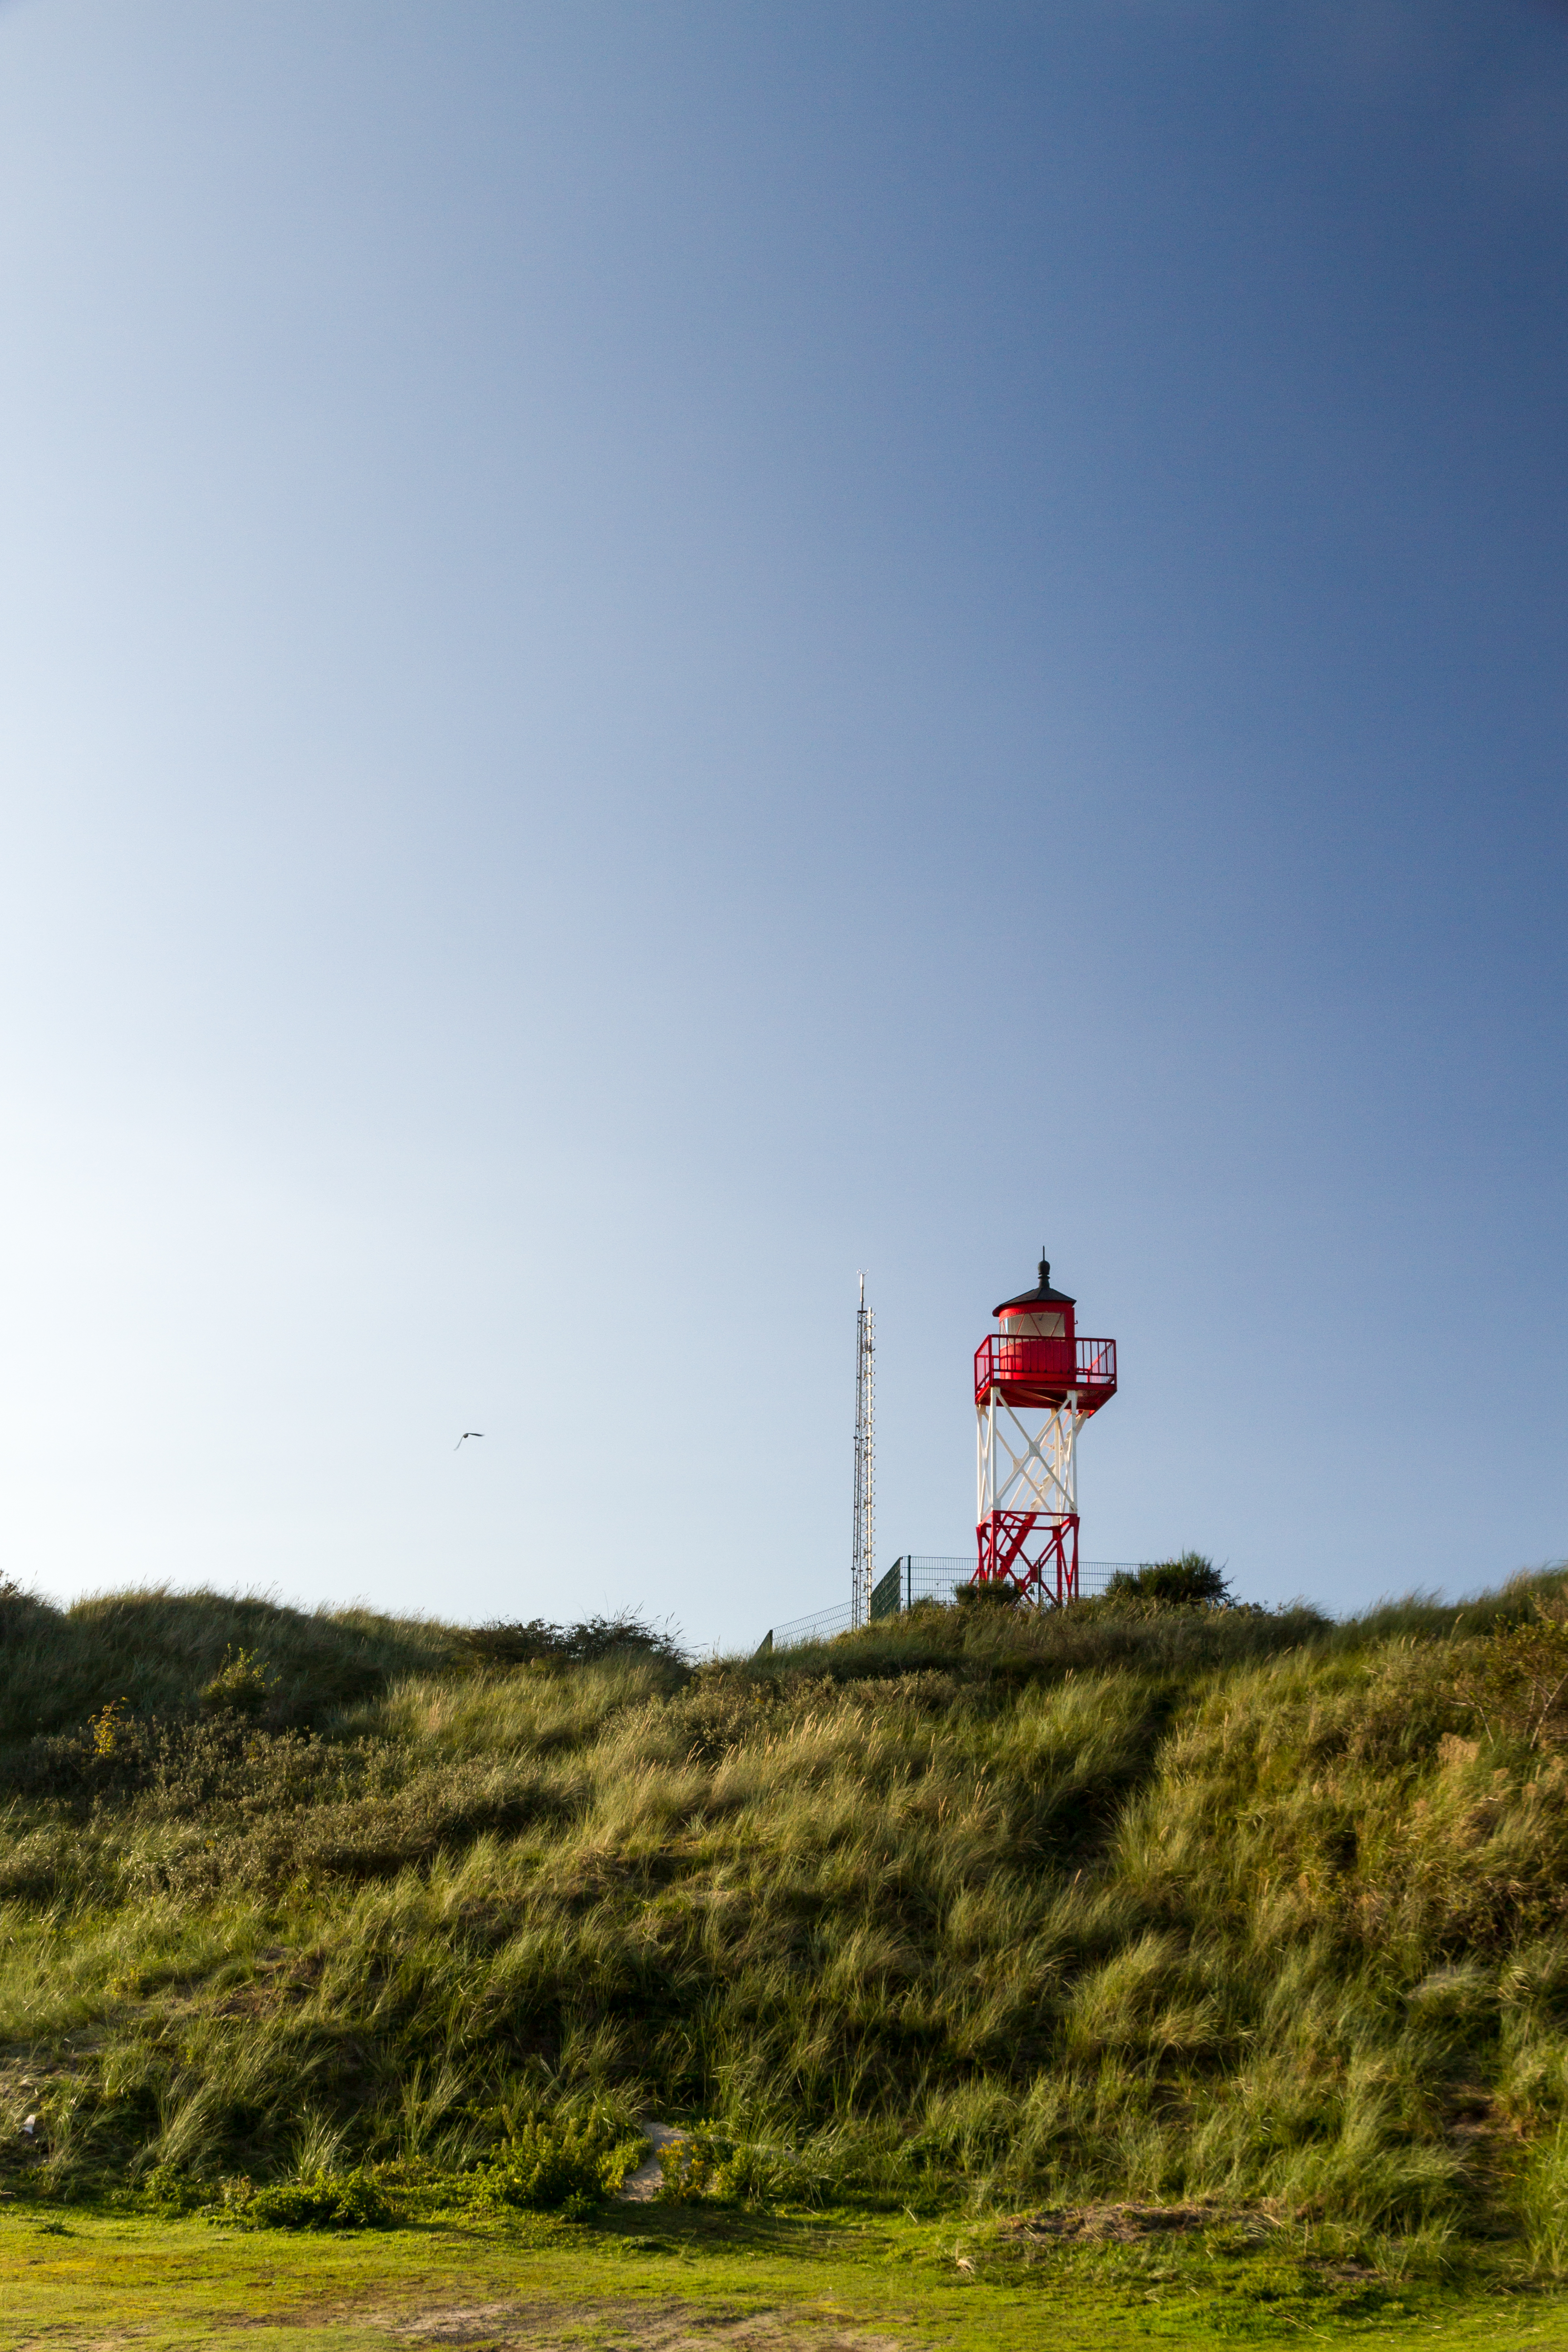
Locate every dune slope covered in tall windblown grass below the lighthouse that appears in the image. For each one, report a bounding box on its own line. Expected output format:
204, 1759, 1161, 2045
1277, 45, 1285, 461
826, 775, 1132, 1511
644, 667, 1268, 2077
0, 1578, 1568, 2274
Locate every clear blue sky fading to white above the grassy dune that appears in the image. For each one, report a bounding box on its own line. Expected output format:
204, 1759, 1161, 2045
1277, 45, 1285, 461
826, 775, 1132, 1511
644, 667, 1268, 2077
0, 0, 1568, 1644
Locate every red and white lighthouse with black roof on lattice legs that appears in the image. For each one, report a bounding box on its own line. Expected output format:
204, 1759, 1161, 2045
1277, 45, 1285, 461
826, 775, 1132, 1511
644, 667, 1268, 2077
975, 1258, 1117, 1602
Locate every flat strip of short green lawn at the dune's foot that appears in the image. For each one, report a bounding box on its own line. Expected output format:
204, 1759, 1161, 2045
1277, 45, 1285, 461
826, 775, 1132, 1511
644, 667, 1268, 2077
0, 2206, 1568, 2352
